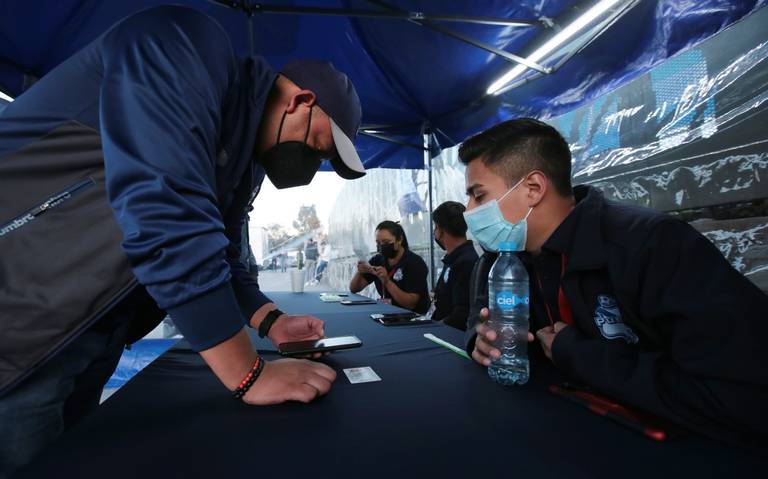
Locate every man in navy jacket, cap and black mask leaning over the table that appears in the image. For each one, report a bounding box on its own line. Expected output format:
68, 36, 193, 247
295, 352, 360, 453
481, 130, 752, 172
0, 7, 365, 475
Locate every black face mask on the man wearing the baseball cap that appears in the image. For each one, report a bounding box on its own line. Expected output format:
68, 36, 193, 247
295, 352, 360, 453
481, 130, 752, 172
260, 107, 323, 190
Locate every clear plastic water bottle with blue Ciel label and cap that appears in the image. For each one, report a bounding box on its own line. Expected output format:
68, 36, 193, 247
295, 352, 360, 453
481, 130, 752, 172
488, 243, 529, 386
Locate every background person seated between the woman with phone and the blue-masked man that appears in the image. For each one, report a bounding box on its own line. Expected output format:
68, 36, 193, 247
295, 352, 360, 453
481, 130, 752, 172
432, 201, 477, 331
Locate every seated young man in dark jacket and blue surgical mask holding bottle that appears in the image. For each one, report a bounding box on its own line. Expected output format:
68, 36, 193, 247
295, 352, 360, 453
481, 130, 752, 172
459, 119, 768, 447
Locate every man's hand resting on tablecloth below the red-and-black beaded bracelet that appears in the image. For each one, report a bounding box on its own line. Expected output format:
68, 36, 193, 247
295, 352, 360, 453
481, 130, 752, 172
243, 359, 336, 406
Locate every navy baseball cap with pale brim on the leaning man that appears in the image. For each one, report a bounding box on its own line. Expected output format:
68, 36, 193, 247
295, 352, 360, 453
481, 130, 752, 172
280, 60, 365, 180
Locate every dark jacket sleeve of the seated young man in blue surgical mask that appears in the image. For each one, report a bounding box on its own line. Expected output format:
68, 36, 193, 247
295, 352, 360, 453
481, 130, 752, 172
552, 220, 768, 446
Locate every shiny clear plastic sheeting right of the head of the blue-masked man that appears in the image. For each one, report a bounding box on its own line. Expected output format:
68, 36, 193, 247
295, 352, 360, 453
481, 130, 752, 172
548, 5, 768, 211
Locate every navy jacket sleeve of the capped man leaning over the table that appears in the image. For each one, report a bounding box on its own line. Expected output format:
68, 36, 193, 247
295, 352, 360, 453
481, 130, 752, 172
100, 7, 245, 350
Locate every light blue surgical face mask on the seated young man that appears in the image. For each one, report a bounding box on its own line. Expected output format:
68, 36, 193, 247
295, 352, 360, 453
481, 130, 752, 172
464, 178, 533, 252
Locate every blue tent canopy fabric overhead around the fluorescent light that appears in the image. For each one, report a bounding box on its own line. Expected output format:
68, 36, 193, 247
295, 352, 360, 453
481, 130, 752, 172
0, 0, 768, 168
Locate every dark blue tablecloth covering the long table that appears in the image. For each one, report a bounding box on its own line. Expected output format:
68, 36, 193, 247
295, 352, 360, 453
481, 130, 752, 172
20, 293, 768, 479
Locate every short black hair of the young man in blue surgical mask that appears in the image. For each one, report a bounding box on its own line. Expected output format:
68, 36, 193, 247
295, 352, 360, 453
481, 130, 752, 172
459, 118, 573, 196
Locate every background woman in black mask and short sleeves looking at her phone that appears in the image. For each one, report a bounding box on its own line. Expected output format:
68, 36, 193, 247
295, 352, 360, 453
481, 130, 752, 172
349, 221, 429, 314
